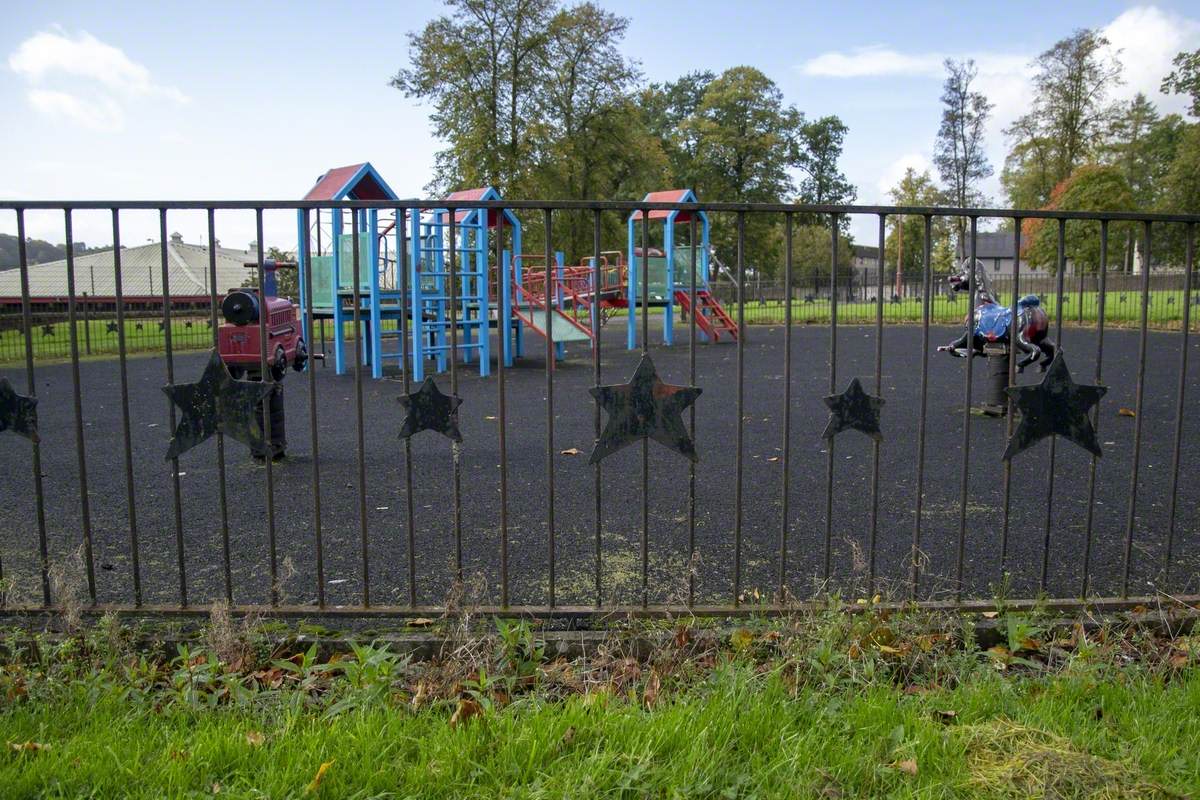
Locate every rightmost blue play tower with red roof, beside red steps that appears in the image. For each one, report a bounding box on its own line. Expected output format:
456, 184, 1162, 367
625, 190, 709, 350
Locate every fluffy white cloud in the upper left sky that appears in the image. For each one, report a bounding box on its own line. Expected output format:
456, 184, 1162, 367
8, 29, 188, 132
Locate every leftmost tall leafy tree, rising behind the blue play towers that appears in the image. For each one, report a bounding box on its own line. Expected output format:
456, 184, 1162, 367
390, 0, 556, 192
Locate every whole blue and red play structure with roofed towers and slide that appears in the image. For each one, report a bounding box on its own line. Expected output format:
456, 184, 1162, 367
298, 163, 737, 380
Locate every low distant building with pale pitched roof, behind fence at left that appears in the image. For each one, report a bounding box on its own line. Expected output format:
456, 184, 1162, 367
0, 234, 258, 314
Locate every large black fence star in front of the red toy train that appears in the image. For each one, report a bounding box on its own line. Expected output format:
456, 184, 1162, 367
162, 350, 271, 461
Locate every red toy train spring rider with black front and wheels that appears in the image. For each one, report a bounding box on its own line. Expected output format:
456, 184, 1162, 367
217, 260, 308, 381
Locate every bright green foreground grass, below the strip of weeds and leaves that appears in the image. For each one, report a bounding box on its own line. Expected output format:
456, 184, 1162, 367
0, 664, 1200, 798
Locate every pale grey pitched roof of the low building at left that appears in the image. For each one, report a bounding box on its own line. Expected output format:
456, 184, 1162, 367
0, 234, 258, 303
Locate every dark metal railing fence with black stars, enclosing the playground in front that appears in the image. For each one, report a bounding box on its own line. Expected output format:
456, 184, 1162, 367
0, 200, 1200, 616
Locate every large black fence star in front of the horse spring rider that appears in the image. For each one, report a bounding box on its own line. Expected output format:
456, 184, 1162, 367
1003, 348, 1108, 459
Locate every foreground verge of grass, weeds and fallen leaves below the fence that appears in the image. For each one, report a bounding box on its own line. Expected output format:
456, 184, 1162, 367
0, 614, 1200, 799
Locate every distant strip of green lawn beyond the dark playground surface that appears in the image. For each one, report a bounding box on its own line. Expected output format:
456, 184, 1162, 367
0, 288, 1200, 363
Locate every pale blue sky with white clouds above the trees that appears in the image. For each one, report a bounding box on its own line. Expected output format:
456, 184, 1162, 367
0, 0, 1200, 249
